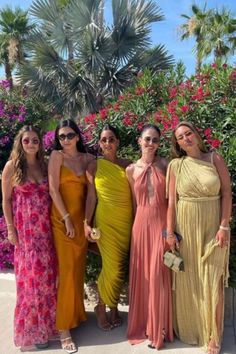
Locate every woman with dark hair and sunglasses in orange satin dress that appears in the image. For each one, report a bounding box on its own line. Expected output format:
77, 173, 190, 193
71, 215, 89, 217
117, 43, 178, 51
48, 120, 93, 353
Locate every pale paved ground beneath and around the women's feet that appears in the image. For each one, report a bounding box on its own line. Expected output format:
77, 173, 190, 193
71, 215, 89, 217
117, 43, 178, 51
0, 272, 236, 354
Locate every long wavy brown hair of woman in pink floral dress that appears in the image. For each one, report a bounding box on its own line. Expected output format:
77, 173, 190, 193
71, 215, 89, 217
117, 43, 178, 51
9, 125, 47, 184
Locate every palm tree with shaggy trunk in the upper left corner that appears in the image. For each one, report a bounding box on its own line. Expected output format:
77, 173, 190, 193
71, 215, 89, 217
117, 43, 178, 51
0, 6, 33, 83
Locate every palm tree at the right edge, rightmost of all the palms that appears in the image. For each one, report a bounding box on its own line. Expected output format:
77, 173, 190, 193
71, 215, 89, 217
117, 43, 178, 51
200, 8, 236, 60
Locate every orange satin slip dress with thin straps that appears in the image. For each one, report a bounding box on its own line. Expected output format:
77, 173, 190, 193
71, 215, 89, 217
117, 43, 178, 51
51, 166, 87, 330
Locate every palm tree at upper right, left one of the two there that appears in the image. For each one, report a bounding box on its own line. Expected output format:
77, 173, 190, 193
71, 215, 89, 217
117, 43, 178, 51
180, 3, 212, 72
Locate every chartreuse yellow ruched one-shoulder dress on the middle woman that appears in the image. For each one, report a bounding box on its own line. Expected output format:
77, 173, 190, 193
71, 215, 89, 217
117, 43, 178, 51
95, 159, 132, 307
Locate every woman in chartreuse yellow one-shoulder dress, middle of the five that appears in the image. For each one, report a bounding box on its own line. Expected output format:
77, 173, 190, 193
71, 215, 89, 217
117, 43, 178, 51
84, 125, 132, 331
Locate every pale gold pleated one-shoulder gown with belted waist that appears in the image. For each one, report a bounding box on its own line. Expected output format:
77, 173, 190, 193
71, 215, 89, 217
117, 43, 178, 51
168, 157, 229, 349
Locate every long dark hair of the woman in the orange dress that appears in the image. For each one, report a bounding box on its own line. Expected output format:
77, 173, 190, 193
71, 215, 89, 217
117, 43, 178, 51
54, 119, 87, 152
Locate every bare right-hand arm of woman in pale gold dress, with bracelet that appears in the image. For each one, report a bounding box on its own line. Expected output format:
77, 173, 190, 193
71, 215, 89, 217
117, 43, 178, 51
213, 153, 232, 247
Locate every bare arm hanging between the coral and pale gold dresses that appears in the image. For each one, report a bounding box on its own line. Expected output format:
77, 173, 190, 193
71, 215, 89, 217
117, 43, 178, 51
166, 170, 179, 251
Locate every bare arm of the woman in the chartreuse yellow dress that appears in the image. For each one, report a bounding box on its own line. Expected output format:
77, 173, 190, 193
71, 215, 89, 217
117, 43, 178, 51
84, 160, 97, 242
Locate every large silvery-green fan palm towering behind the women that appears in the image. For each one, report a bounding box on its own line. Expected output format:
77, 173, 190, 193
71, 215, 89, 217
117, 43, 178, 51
19, 0, 173, 115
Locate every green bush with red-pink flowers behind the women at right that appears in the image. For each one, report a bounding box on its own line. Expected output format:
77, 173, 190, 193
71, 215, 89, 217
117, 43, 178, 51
84, 63, 236, 198
